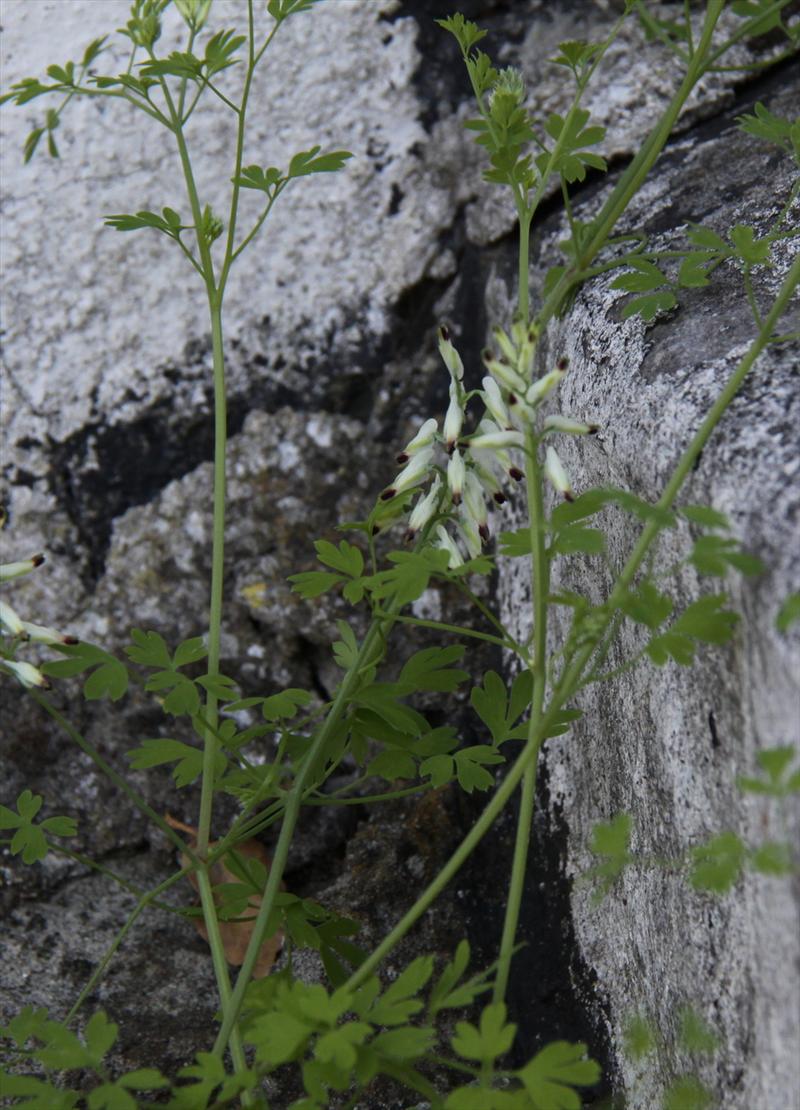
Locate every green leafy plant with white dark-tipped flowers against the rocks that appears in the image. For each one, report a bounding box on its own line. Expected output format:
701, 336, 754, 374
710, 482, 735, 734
0, 0, 800, 1110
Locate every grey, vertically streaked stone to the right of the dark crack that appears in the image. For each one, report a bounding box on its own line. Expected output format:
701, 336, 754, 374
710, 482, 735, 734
500, 69, 800, 1108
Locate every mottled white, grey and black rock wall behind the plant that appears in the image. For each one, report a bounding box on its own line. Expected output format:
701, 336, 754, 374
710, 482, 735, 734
0, 0, 798, 1108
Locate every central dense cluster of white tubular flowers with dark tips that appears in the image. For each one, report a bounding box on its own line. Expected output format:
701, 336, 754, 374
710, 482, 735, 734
381, 323, 597, 569
